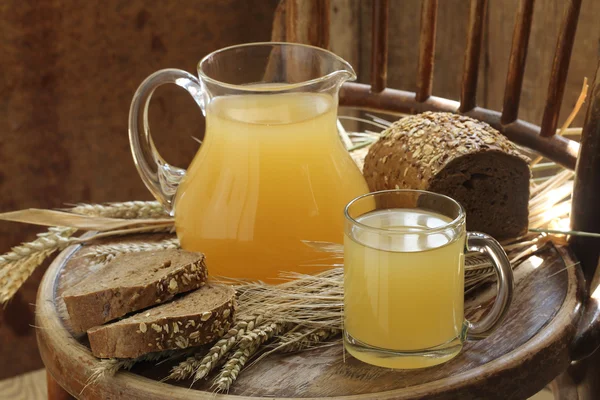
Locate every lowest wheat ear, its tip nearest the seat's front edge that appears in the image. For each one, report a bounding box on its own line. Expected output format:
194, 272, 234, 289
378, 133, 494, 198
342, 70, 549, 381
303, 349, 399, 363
212, 322, 289, 392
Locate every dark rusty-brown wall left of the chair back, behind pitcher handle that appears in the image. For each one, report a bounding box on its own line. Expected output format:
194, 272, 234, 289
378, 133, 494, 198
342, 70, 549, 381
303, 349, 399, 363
0, 0, 277, 379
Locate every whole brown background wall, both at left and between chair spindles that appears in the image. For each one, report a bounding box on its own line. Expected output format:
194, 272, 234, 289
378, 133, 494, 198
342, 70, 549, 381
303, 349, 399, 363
0, 0, 600, 379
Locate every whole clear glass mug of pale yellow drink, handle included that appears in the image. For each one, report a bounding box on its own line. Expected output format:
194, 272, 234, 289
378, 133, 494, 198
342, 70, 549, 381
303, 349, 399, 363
344, 190, 513, 369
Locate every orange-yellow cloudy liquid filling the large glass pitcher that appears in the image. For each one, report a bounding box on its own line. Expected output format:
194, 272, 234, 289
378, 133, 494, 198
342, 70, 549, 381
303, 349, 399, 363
175, 93, 368, 282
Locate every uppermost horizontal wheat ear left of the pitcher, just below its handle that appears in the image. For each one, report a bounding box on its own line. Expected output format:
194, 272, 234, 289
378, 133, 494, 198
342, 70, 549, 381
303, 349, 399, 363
68, 201, 169, 219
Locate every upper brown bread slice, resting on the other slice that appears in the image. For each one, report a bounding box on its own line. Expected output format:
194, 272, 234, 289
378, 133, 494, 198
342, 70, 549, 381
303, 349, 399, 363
63, 250, 208, 333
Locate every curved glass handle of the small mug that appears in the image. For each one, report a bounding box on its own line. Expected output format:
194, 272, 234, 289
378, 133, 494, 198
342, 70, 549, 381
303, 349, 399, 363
466, 232, 514, 340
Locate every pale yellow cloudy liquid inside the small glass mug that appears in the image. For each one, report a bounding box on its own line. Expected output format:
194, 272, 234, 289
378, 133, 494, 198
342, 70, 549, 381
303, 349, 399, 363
344, 209, 465, 368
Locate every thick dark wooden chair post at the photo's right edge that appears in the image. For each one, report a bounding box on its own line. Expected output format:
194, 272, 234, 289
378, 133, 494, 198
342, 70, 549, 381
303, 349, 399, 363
571, 61, 600, 284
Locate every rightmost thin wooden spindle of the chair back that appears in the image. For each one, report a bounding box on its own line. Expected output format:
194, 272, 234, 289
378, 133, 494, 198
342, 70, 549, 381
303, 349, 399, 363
540, 0, 581, 137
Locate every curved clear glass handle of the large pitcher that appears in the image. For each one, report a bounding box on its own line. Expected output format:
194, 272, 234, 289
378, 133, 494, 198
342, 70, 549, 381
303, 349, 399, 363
129, 69, 205, 216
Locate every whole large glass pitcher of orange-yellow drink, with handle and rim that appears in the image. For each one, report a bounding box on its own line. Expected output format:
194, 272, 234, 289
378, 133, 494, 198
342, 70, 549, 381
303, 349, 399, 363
129, 42, 368, 282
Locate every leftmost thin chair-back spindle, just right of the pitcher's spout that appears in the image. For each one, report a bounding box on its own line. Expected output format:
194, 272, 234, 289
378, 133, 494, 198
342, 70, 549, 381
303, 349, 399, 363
371, 0, 389, 93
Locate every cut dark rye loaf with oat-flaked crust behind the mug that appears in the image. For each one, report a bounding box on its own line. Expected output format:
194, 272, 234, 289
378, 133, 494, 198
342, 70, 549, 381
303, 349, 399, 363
363, 112, 531, 239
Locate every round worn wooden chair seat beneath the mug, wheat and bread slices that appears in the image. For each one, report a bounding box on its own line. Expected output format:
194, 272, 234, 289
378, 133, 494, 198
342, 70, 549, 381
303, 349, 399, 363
36, 235, 582, 400
